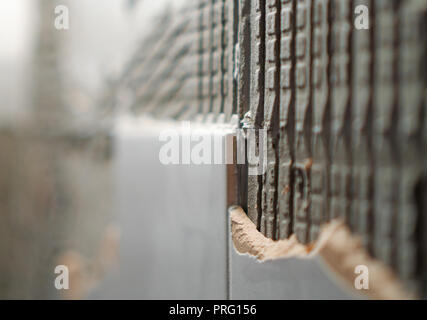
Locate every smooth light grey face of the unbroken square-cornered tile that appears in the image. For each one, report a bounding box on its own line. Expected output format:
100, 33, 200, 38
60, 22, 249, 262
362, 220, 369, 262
90, 118, 231, 299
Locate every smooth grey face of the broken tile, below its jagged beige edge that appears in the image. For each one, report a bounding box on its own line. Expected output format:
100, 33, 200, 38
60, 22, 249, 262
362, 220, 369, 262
230, 239, 360, 300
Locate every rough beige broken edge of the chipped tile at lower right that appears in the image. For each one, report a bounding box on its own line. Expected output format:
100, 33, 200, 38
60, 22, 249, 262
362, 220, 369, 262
229, 206, 416, 299
